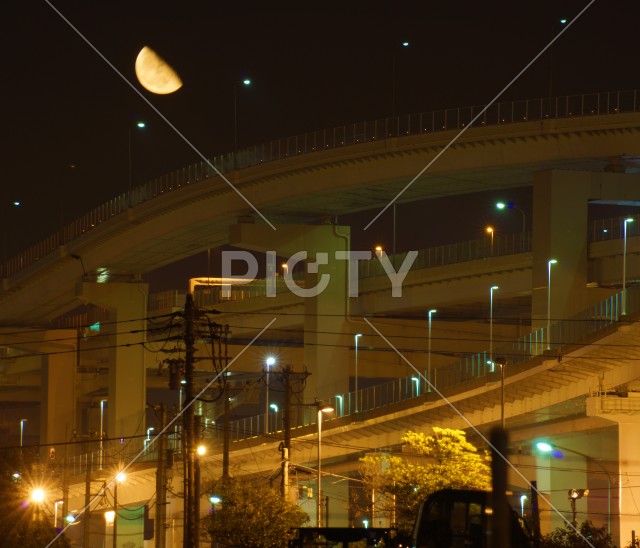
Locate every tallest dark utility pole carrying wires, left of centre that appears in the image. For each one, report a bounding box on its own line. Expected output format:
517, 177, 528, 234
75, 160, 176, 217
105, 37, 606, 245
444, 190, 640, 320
182, 293, 197, 548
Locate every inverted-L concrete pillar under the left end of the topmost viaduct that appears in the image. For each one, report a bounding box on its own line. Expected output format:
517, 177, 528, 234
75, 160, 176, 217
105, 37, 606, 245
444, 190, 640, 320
78, 282, 148, 447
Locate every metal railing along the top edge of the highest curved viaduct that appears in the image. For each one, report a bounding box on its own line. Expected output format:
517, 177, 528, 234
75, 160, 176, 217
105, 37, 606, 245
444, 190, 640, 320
0, 90, 640, 278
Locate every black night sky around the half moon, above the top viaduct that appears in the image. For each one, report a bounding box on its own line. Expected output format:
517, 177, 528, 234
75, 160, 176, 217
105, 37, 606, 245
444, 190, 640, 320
0, 0, 640, 288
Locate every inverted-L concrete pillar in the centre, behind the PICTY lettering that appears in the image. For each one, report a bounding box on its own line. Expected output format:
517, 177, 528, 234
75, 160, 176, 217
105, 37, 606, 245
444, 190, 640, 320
229, 224, 352, 399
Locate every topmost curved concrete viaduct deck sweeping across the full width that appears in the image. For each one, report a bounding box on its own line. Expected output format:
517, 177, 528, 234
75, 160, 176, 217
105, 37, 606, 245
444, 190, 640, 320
0, 105, 640, 325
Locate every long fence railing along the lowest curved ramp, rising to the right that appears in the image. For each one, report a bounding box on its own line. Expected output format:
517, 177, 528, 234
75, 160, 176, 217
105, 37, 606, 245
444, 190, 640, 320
67, 285, 640, 474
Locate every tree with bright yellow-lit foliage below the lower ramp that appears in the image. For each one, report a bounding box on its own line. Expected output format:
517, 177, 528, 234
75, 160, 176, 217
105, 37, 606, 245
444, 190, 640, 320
360, 426, 491, 529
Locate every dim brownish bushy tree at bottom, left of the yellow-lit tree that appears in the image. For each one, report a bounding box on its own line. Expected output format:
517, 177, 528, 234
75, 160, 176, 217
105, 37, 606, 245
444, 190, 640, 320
203, 480, 309, 548
